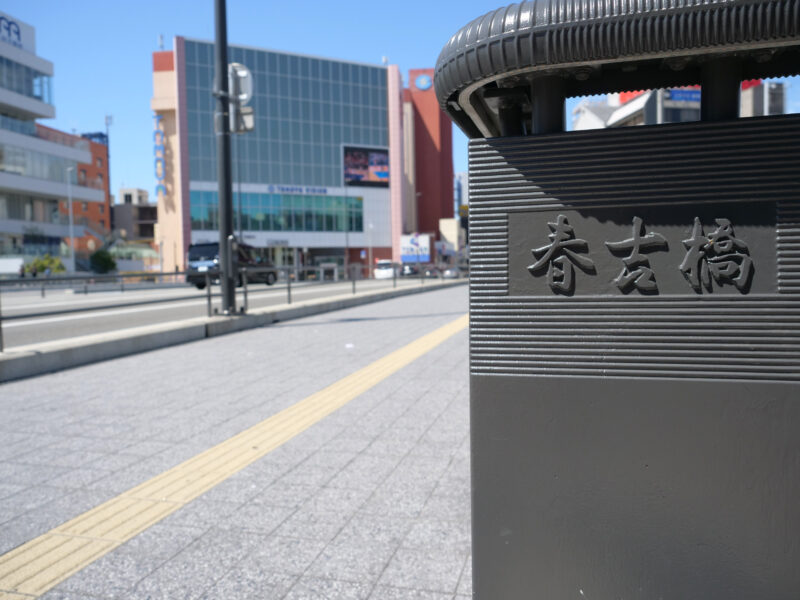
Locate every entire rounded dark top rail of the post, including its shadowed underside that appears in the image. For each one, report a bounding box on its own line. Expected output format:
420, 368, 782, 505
434, 0, 800, 137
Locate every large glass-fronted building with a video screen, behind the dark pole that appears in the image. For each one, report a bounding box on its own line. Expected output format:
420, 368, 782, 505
151, 37, 452, 270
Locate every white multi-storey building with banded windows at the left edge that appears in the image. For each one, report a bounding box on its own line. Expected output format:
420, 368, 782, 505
0, 12, 108, 270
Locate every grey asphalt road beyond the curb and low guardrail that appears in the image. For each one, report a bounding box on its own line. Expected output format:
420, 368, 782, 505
0, 279, 440, 348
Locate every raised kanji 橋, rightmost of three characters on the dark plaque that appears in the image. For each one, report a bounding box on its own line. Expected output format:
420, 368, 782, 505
680, 217, 753, 292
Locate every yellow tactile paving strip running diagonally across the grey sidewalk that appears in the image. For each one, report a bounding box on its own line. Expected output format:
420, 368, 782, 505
0, 315, 468, 600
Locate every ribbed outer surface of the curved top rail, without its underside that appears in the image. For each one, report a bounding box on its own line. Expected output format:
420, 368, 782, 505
435, 0, 800, 109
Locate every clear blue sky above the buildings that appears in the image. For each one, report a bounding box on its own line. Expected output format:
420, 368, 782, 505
3, 0, 800, 199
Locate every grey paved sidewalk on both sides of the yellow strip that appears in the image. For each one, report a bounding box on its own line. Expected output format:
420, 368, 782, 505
0, 286, 471, 600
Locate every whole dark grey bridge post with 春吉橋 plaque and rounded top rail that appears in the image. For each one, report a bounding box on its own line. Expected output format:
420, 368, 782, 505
435, 0, 800, 600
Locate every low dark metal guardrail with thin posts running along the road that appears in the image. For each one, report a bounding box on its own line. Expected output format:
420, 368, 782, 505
0, 263, 468, 352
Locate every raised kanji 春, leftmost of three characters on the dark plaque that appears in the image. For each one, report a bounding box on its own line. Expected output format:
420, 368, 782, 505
528, 215, 595, 294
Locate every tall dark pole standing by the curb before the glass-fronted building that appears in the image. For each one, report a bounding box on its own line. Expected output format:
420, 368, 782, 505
214, 0, 236, 315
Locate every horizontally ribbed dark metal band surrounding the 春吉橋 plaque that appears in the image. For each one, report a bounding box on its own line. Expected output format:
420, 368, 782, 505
470, 116, 800, 381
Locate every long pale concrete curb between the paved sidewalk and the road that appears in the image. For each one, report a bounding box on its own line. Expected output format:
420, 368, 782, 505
0, 279, 468, 382
